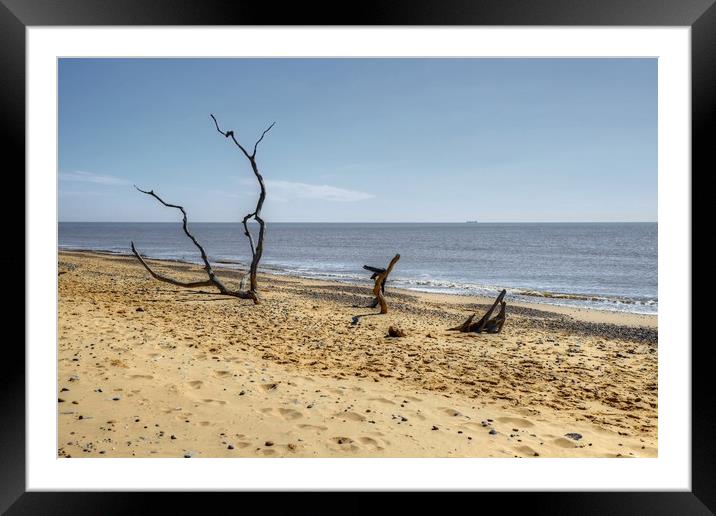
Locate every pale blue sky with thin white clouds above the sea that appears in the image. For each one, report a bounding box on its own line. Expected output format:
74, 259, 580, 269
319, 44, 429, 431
58, 59, 657, 222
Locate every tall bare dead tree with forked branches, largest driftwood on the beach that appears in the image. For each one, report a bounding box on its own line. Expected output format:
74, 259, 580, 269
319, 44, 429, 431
131, 114, 276, 304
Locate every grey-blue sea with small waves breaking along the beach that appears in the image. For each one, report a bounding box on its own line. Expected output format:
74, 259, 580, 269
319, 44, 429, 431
59, 222, 658, 313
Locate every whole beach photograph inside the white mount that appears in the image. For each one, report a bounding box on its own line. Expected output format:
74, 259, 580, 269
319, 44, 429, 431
58, 58, 659, 459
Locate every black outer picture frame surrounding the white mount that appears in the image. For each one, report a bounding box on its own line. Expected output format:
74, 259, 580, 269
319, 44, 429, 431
0, 0, 716, 515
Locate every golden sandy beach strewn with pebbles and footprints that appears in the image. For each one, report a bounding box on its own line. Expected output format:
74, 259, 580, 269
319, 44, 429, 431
57, 252, 657, 457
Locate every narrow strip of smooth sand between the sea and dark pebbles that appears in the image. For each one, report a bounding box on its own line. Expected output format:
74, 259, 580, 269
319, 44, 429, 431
58, 249, 658, 328
